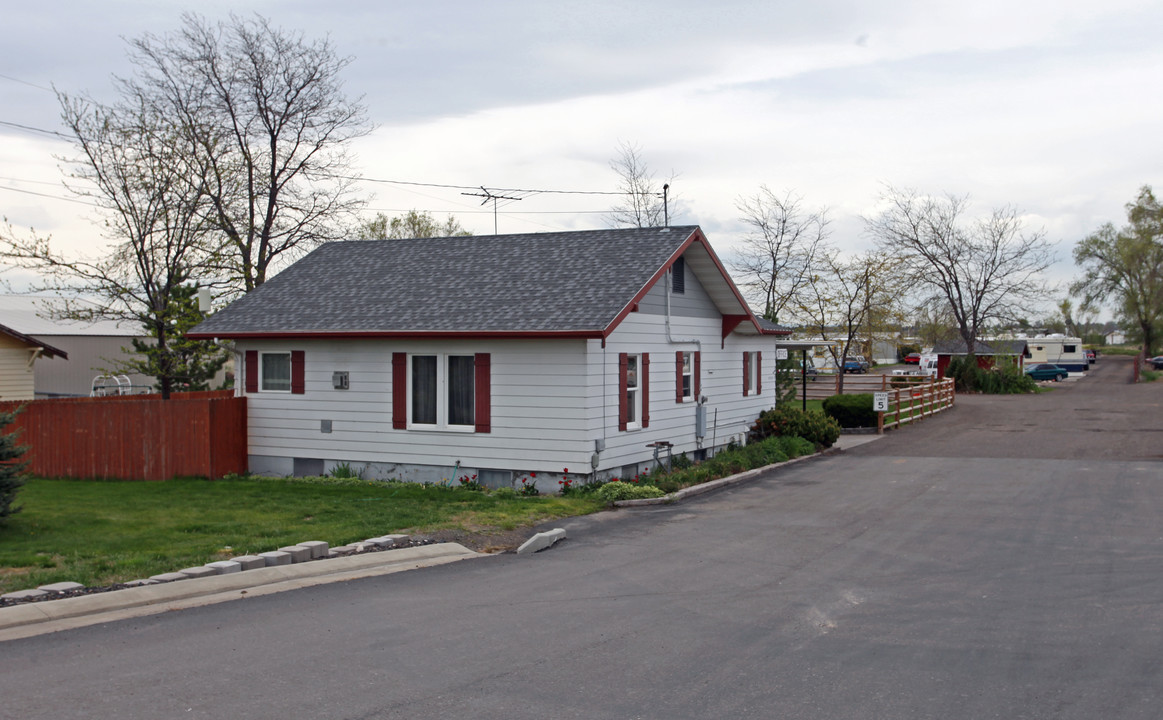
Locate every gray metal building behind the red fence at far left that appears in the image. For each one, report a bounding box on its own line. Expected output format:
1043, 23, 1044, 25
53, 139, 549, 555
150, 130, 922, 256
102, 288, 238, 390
0, 295, 154, 398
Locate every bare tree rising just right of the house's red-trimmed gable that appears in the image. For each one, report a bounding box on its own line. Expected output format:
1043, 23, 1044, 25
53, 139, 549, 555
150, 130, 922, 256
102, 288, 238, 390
733, 186, 828, 322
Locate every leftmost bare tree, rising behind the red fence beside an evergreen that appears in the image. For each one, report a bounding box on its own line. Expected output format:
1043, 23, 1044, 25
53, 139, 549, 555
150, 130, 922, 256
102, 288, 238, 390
0, 95, 221, 398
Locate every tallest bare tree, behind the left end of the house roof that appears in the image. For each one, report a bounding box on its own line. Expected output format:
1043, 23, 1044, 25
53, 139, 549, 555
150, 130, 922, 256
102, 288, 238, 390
129, 14, 371, 292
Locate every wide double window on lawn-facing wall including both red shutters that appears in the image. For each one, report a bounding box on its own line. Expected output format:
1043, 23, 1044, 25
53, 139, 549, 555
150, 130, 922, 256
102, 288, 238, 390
392, 352, 491, 433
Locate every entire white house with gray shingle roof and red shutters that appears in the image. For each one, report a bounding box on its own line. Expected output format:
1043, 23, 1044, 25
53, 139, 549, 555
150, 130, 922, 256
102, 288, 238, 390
190, 226, 789, 490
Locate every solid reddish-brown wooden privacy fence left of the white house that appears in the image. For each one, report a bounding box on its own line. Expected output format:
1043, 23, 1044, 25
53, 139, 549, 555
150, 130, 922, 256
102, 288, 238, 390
0, 390, 247, 480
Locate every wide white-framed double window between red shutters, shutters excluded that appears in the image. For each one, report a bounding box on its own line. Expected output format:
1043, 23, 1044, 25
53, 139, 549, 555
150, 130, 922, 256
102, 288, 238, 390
408, 355, 476, 429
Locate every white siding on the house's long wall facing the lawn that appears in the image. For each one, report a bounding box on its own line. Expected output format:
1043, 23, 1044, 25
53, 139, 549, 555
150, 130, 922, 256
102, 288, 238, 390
238, 340, 593, 477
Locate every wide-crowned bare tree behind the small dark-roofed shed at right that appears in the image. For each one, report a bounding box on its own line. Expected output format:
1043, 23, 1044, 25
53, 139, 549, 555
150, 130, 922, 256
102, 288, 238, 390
865, 187, 1054, 355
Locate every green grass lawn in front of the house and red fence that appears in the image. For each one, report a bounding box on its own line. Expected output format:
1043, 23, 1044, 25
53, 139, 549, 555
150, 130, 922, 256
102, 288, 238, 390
0, 478, 602, 593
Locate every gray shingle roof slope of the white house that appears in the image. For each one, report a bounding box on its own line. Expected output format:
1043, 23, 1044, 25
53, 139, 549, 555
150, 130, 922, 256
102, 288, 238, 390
191, 226, 698, 337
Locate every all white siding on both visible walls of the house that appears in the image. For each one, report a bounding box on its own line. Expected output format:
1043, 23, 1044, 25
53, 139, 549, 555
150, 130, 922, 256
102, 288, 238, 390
237, 289, 776, 481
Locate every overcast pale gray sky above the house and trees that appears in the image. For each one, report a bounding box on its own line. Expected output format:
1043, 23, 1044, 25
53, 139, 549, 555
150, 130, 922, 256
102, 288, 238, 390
0, 0, 1163, 318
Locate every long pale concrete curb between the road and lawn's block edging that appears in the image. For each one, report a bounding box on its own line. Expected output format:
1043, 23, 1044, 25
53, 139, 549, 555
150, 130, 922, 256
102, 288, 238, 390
0, 542, 481, 641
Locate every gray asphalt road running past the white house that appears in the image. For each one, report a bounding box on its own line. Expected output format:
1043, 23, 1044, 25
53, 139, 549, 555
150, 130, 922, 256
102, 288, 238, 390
0, 359, 1163, 720
